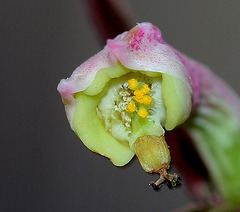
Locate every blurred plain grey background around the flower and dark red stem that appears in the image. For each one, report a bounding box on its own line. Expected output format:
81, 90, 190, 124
0, 0, 240, 212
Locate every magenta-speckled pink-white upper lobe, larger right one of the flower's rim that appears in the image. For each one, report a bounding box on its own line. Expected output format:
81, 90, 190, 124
107, 23, 191, 90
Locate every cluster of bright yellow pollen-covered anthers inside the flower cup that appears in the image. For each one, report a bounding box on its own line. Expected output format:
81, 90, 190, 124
126, 79, 152, 118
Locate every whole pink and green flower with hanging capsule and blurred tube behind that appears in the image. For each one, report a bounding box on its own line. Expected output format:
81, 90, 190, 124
57, 23, 240, 208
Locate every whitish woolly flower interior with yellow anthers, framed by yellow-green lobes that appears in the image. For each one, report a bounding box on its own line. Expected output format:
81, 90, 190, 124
96, 73, 165, 145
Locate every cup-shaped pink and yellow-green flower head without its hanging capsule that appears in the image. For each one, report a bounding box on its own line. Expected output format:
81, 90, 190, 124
58, 23, 192, 166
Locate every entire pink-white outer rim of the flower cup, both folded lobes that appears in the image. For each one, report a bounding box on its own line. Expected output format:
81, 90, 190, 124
57, 23, 192, 126
